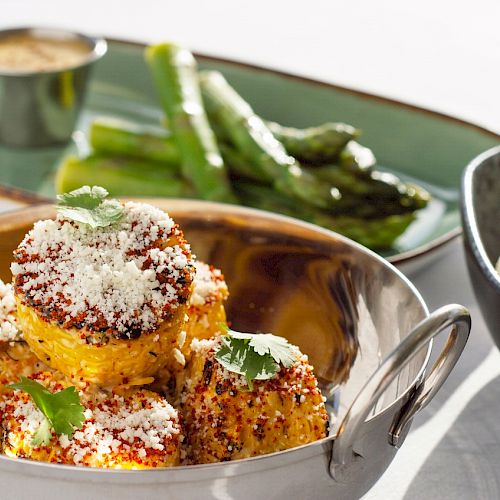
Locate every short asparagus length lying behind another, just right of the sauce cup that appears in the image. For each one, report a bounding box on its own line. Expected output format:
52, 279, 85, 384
89, 117, 180, 168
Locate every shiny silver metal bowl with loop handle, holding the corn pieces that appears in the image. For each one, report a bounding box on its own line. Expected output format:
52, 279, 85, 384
0, 200, 470, 499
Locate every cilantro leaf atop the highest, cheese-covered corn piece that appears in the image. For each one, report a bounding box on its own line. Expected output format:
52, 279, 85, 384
57, 186, 123, 229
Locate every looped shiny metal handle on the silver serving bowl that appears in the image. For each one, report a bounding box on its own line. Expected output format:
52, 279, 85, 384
329, 304, 471, 482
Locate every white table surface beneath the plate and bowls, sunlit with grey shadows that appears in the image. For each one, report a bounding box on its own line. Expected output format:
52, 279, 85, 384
0, 0, 500, 500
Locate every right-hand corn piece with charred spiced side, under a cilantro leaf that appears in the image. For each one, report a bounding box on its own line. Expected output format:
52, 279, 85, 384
181, 338, 328, 464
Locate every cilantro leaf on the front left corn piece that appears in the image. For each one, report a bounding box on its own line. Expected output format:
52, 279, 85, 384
6, 377, 85, 446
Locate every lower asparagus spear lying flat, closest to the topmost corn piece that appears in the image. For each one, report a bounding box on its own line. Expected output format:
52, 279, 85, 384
56, 155, 193, 198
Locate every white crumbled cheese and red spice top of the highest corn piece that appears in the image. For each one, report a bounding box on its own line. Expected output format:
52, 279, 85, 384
11, 202, 193, 338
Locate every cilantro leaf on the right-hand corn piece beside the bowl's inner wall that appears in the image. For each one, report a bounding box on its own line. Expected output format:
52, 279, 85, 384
215, 330, 297, 391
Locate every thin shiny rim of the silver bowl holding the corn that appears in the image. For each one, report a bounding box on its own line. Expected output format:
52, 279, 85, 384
0, 197, 433, 476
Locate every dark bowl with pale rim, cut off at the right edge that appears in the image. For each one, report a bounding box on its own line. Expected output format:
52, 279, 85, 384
461, 146, 500, 348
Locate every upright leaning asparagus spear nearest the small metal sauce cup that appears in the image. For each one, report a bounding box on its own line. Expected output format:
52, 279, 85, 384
146, 43, 235, 202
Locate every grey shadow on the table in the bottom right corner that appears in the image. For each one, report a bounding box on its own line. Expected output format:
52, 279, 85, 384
404, 377, 500, 500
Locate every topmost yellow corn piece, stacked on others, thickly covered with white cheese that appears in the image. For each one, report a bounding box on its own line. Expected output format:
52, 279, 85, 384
12, 202, 193, 387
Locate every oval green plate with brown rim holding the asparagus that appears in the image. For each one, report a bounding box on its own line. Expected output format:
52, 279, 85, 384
0, 41, 500, 264
